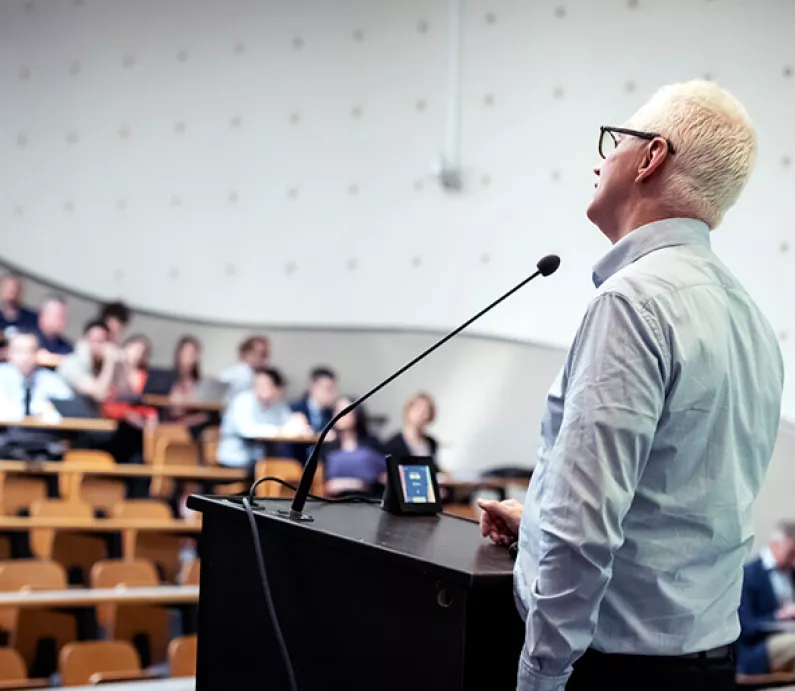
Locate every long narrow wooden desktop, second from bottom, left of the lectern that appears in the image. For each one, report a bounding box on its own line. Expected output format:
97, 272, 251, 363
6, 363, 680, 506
0, 585, 199, 609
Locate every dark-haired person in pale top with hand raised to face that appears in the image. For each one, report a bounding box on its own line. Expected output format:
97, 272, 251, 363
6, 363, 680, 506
58, 320, 129, 403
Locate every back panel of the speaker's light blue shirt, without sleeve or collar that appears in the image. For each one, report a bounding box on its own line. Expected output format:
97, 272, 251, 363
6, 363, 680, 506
595, 223, 783, 652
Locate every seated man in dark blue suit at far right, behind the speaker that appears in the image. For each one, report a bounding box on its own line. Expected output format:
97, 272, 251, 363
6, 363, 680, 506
737, 522, 795, 674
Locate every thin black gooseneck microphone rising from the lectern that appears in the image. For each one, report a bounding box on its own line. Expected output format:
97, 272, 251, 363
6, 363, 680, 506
285, 254, 560, 521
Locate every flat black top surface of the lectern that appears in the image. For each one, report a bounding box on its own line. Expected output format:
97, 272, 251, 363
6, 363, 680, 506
188, 496, 513, 581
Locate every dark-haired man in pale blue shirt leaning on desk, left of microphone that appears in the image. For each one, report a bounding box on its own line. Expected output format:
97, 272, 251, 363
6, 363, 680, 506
218, 367, 293, 468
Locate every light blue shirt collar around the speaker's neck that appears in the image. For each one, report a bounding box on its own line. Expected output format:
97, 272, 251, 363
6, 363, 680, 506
593, 218, 709, 288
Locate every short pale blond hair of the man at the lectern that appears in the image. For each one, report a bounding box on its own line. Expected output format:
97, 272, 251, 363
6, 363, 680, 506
627, 80, 756, 228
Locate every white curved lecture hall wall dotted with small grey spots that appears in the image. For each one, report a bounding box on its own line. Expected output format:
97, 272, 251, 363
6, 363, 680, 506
0, 0, 795, 548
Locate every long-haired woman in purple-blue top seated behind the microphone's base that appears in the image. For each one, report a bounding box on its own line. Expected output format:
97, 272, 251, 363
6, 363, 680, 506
322, 397, 386, 496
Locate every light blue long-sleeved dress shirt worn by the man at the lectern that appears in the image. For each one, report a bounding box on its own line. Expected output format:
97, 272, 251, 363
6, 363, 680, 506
515, 219, 783, 691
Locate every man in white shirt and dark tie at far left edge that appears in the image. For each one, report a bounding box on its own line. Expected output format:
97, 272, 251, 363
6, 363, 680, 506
0, 330, 73, 422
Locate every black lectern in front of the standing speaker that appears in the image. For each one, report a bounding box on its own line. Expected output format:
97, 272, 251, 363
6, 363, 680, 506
188, 496, 524, 691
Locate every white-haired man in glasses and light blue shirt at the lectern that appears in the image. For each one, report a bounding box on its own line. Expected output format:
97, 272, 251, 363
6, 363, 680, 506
481, 81, 783, 691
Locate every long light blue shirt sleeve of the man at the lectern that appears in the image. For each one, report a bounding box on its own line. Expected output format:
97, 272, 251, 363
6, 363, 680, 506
518, 293, 669, 691
